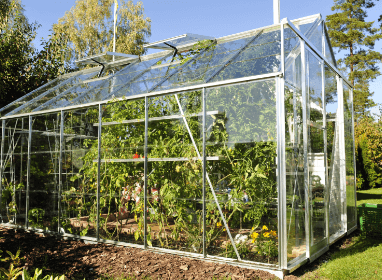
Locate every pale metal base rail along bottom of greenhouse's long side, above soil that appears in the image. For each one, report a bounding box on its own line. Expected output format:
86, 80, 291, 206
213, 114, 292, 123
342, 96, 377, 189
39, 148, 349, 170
2, 223, 285, 279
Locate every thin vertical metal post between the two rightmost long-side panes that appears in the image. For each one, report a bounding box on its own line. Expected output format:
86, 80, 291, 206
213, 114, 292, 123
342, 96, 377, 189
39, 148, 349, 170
202, 88, 207, 258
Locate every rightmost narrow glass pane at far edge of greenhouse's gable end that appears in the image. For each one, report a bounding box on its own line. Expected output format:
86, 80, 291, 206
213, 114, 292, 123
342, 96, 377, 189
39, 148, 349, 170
343, 85, 356, 230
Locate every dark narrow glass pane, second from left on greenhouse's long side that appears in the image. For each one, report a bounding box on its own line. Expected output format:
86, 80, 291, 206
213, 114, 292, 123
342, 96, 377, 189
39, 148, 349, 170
27, 113, 61, 231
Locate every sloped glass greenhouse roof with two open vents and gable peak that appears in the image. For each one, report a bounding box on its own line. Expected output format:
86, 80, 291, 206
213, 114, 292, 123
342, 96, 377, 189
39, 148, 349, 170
0, 14, 348, 118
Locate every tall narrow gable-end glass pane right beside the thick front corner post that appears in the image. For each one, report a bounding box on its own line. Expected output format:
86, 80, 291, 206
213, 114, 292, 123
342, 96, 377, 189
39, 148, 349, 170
284, 41, 306, 262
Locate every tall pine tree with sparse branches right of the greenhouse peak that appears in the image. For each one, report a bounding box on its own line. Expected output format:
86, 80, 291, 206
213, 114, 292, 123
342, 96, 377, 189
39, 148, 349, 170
326, 0, 382, 118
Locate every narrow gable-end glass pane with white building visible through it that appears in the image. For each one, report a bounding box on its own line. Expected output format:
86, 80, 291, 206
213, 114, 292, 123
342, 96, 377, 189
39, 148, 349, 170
305, 48, 327, 256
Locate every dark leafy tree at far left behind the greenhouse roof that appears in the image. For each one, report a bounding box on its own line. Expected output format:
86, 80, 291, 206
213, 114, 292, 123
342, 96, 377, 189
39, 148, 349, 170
0, 0, 71, 108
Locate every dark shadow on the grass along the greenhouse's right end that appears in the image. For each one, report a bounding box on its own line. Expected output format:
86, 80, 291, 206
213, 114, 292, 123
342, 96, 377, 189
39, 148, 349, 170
291, 230, 382, 277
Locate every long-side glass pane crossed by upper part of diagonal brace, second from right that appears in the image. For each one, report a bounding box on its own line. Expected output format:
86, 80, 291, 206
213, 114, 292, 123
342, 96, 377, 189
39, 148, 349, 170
147, 90, 203, 253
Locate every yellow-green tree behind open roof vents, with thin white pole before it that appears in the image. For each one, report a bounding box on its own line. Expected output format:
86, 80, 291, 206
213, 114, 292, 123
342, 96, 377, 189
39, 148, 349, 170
53, 0, 151, 62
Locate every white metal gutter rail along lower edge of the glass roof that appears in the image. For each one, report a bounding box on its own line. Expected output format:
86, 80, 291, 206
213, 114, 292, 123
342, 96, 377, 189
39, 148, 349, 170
0, 72, 282, 120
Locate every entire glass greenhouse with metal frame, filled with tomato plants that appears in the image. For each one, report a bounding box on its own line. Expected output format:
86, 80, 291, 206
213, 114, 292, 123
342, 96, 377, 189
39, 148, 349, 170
0, 14, 357, 277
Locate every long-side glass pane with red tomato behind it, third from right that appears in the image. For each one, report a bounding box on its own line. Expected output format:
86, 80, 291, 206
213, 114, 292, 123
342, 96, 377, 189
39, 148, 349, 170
99, 99, 145, 245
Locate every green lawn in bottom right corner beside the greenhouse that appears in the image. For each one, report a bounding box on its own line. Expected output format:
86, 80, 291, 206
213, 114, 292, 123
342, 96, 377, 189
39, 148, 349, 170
301, 235, 382, 280
